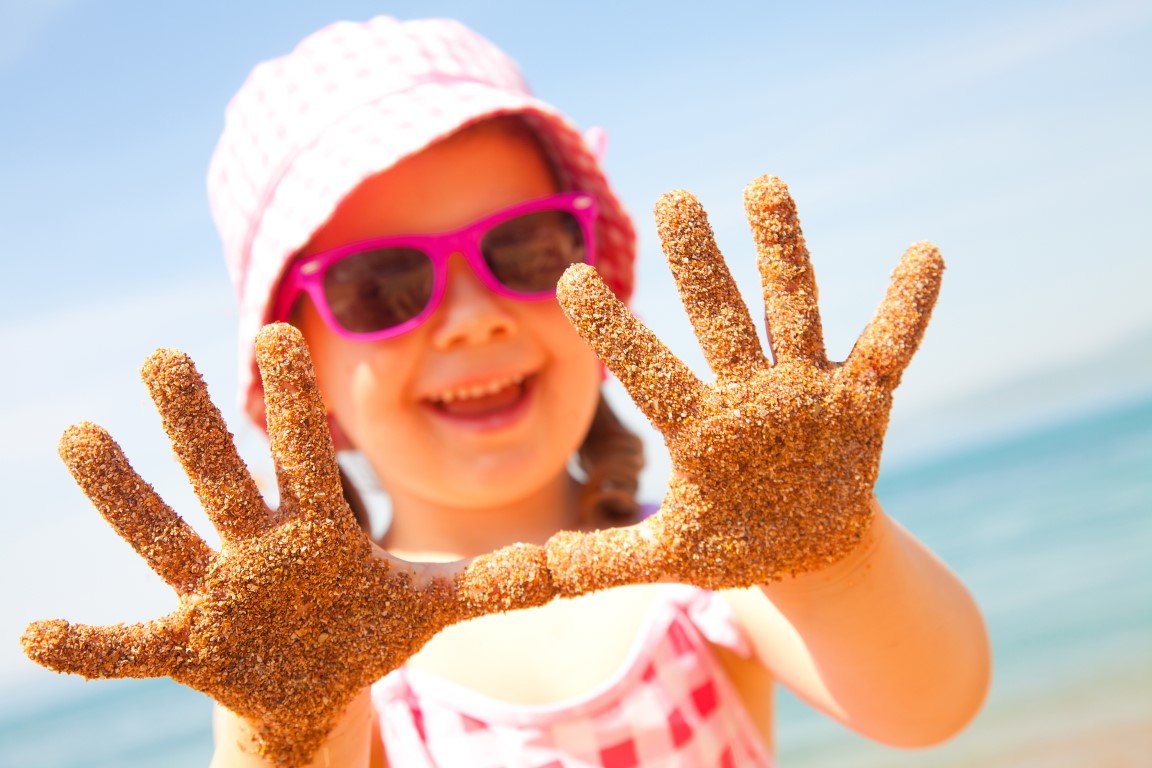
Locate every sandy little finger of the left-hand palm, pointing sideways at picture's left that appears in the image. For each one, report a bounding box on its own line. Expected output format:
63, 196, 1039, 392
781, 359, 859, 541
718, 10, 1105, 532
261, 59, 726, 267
20, 618, 182, 678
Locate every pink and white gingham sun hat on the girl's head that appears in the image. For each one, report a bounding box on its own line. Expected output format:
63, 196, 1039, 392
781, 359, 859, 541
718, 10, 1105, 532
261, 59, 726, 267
209, 16, 636, 426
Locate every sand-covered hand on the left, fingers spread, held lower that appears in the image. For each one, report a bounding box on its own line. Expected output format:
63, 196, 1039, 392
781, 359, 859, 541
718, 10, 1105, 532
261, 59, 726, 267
23, 326, 553, 766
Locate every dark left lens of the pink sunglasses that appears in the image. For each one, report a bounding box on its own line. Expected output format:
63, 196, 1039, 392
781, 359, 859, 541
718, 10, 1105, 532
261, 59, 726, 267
324, 248, 433, 333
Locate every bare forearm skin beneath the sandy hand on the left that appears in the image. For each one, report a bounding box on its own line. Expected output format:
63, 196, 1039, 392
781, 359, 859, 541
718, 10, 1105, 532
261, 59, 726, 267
211, 689, 376, 768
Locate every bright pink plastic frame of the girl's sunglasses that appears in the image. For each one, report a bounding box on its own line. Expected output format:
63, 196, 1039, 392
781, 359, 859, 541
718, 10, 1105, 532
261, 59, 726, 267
272, 192, 597, 342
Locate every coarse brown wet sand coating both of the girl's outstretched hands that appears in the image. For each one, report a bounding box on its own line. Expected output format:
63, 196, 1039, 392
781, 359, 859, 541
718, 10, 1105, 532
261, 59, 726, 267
23, 177, 943, 766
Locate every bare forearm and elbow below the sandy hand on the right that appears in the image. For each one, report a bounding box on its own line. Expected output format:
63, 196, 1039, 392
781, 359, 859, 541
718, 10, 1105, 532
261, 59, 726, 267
737, 504, 990, 746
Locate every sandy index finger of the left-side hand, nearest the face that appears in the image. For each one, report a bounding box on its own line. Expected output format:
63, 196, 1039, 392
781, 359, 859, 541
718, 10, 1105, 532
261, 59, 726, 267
256, 322, 356, 526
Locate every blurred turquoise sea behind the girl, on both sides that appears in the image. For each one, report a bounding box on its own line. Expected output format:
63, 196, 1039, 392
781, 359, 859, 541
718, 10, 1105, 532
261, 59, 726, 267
0, 393, 1152, 768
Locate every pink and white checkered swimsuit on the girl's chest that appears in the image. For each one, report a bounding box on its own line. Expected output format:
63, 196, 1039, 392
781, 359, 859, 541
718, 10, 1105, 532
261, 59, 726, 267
372, 585, 773, 768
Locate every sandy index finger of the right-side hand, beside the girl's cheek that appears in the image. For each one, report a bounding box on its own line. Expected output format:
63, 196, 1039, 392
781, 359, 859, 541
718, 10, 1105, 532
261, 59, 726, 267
556, 264, 704, 432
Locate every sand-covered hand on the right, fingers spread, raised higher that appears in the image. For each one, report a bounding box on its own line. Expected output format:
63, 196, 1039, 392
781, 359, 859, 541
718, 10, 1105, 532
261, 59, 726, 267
548, 176, 943, 594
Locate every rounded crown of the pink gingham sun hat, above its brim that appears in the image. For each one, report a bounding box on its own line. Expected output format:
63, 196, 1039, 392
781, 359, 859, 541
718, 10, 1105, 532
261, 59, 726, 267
209, 16, 530, 296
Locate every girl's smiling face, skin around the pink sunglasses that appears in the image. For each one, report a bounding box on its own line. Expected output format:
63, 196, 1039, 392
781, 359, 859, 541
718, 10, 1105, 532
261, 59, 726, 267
297, 126, 600, 511
